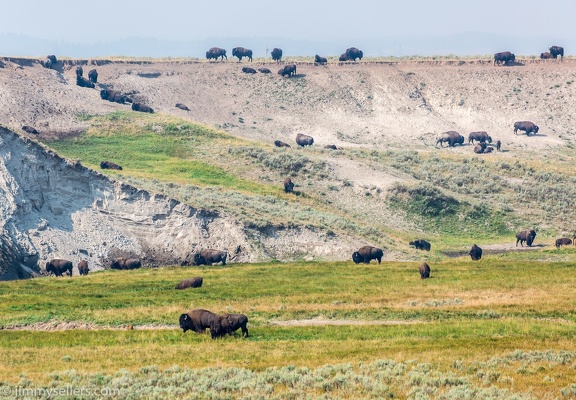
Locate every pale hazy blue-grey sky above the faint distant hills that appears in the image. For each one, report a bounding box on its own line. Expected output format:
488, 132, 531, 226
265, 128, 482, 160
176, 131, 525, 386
0, 0, 576, 57
